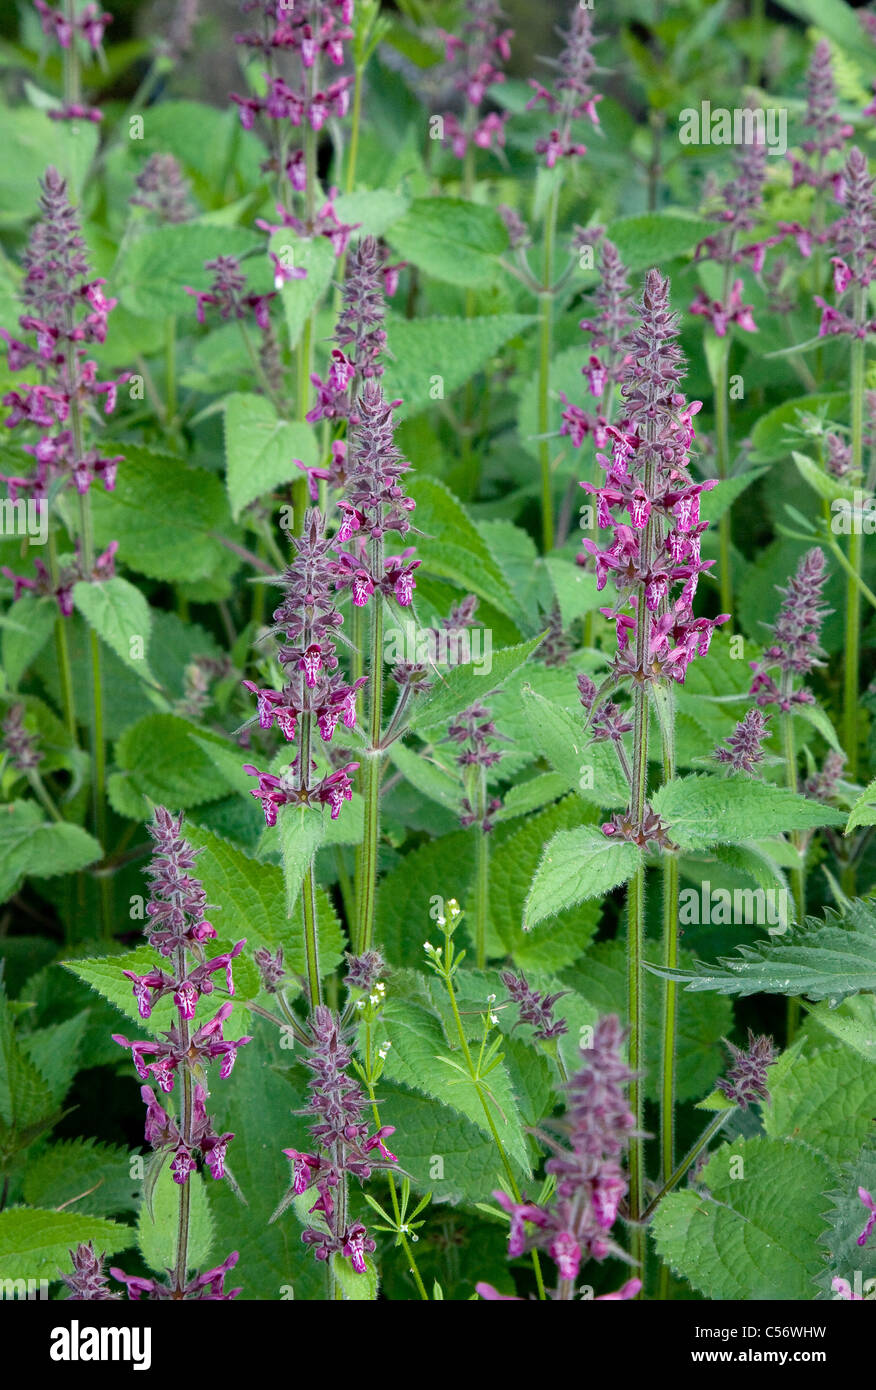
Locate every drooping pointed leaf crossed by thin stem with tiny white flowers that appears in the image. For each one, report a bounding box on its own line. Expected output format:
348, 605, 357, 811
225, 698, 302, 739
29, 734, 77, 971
381, 999, 530, 1176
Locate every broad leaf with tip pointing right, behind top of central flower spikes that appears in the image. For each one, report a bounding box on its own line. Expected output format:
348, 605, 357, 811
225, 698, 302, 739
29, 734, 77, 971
382, 314, 535, 417
